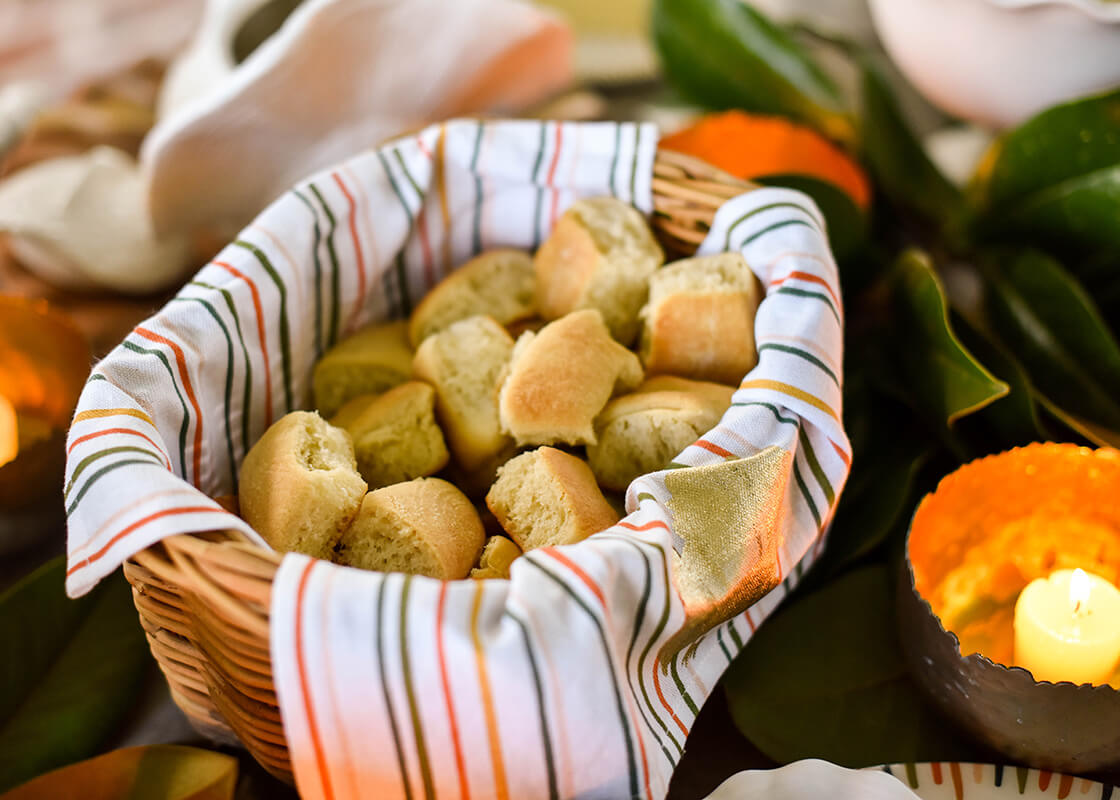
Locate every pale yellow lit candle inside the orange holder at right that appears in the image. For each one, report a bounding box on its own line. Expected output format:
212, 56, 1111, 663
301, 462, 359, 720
1015, 569, 1120, 683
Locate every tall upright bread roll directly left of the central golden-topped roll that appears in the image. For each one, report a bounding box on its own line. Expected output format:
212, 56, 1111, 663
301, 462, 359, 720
412, 317, 513, 471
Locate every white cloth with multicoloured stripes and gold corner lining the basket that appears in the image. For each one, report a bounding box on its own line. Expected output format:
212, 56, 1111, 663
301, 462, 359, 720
65, 120, 850, 798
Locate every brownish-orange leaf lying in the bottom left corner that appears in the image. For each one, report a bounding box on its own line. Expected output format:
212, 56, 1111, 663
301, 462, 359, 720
0, 744, 237, 800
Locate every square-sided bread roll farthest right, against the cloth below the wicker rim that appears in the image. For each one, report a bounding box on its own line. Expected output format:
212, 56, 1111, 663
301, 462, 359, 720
641, 253, 763, 385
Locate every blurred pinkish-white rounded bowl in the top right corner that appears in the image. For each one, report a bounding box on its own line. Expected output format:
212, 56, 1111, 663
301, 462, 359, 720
870, 0, 1120, 129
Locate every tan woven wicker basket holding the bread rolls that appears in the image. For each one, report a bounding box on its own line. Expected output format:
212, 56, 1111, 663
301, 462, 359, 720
124, 150, 752, 783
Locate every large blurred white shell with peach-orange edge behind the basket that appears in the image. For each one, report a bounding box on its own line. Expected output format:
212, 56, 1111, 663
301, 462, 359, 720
141, 0, 572, 234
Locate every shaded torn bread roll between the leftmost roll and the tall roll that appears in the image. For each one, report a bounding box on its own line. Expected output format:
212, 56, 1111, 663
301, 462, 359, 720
332, 381, 448, 489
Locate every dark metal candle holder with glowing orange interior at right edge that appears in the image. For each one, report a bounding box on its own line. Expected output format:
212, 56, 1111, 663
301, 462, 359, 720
898, 443, 1120, 773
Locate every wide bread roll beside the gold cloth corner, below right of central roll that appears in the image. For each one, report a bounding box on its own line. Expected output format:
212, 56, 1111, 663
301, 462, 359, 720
587, 375, 735, 491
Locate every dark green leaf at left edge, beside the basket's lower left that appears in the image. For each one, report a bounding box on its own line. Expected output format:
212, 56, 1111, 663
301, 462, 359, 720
0, 558, 152, 791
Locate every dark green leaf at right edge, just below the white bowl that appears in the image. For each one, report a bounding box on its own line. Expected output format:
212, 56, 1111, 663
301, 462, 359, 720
973, 90, 1120, 208
